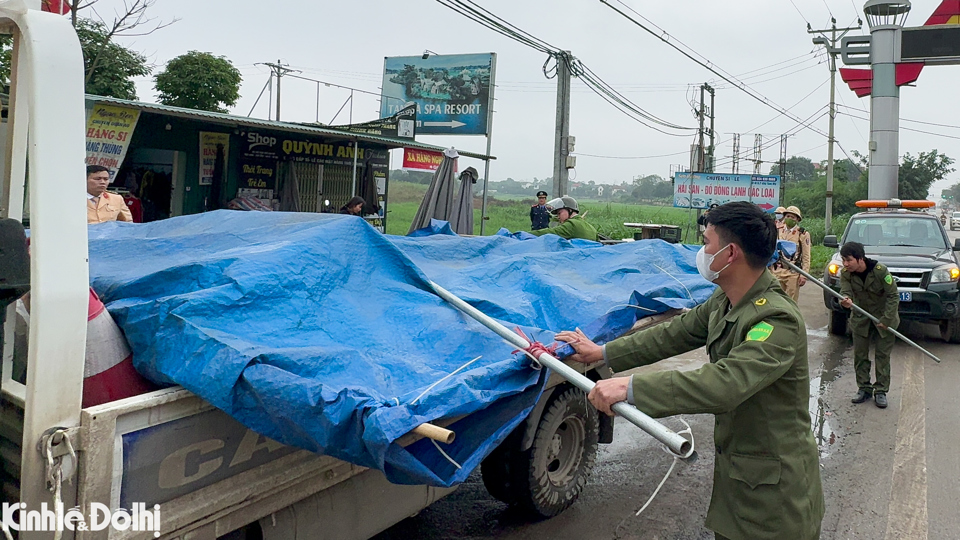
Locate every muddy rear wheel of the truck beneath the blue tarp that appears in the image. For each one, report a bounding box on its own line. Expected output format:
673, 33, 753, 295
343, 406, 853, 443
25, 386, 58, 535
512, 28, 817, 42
480, 388, 600, 518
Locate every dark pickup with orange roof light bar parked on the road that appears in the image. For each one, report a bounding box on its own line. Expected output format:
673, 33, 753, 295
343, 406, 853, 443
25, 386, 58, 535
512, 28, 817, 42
823, 199, 960, 343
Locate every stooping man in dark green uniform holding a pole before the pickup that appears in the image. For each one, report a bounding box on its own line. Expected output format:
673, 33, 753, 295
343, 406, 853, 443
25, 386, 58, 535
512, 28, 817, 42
840, 242, 900, 409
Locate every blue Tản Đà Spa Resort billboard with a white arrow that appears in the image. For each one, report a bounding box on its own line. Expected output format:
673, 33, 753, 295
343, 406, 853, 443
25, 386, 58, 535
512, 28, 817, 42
380, 53, 497, 135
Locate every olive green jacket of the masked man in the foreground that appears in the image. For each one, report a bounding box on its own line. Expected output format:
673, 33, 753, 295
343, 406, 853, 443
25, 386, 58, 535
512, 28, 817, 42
604, 272, 824, 540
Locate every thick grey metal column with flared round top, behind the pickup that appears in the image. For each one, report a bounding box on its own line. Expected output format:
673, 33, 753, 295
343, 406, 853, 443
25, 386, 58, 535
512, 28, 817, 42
863, 0, 910, 200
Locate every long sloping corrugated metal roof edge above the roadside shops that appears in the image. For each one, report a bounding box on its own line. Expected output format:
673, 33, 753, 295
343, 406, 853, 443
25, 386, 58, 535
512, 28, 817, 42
86, 94, 497, 160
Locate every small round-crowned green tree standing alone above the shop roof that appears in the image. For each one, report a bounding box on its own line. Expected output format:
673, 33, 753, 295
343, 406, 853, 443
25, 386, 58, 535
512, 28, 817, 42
154, 51, 242, 112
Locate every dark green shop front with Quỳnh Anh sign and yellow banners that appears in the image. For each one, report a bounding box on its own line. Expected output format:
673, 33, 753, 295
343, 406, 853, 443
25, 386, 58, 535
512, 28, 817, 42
87, 96, 492, 230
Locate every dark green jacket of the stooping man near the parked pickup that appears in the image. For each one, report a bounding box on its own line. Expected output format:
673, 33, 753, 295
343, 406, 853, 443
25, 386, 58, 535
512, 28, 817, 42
840, 263, 900, 336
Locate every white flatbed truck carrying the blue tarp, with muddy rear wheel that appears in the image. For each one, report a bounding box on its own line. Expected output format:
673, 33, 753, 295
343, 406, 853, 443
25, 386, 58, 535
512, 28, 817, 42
0, 0, 613, 540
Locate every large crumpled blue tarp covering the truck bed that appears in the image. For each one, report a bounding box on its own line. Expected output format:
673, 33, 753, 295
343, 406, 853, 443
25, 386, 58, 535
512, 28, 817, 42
90, 211, 714, 486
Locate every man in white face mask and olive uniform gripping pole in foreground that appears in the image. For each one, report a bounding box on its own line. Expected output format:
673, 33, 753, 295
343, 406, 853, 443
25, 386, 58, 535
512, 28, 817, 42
556, 202, 824, 540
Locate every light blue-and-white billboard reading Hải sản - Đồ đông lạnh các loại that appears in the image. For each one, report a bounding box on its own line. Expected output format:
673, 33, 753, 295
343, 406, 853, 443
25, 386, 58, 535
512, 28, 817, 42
673, 173, 780, 212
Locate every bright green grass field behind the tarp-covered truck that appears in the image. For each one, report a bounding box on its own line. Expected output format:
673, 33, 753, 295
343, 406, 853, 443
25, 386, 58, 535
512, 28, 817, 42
387, 182, 848, 276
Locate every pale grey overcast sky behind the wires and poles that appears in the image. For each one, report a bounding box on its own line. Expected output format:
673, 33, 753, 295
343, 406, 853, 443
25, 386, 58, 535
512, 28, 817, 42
97, 0, 960, 196
